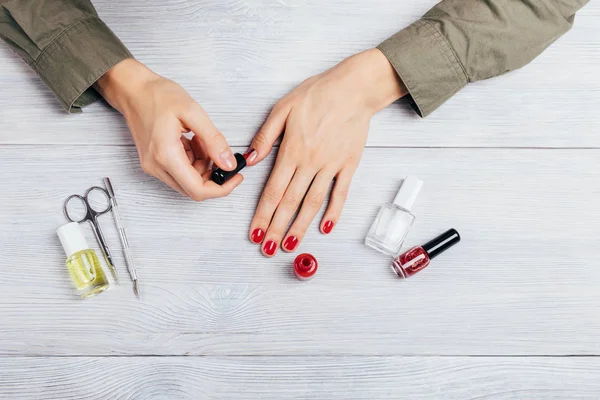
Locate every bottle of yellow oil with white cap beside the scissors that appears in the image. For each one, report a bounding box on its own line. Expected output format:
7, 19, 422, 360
56, 222, 109, 298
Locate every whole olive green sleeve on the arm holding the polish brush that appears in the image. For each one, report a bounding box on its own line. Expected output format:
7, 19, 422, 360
0, 0, 131, 112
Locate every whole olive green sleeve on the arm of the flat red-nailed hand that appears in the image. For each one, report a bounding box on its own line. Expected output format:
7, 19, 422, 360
378, 0, 588, 117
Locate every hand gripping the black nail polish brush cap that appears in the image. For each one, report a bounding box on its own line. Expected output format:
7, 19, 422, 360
95, 59, 243, 201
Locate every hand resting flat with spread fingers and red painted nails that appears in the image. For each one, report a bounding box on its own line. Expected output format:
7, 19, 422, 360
247, 49, 406, 257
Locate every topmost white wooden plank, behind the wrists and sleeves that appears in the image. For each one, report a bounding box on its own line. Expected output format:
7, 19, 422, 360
0, 0, 600, 147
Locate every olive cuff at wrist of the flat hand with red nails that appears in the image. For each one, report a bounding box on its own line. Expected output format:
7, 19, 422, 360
377, 19, 468, 117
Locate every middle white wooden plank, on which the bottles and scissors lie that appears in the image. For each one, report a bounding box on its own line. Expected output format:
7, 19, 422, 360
0, 146, 600, 355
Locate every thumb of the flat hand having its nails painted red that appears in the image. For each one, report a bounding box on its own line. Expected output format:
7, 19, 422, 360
247, 101, 292, 165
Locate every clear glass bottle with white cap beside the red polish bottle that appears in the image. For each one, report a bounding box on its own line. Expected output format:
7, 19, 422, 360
365, 176, 423, 257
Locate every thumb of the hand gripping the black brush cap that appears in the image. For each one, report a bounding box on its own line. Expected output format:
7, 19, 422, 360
181, 104, 237, 171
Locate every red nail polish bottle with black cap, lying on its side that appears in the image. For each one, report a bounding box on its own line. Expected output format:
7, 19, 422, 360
392, 229, 460, 279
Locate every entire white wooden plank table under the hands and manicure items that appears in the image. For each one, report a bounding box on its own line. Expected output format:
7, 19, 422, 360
0, 0, 600, 400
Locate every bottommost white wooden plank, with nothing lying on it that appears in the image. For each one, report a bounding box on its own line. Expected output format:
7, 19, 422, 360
0, 357, 600, 400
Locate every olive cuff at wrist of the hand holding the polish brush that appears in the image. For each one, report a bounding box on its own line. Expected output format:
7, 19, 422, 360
34, 18, 132, 112
